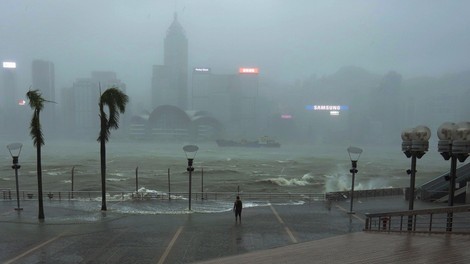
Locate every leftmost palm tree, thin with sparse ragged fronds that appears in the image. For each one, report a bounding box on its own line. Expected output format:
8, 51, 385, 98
26, 90, 52, 219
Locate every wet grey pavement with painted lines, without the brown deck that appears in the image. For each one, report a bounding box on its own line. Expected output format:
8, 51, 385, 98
0, 196, 456, 263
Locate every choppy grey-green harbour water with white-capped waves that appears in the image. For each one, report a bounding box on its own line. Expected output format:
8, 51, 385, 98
0, 140, 450, 196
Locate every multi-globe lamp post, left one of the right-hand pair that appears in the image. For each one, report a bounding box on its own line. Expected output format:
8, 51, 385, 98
401, 126, 431, 230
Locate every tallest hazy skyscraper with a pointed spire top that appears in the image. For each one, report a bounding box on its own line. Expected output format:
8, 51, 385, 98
152, 13, 188, 110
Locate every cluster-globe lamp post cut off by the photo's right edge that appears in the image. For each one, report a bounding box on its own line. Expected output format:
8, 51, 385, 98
437, 122, 470, 231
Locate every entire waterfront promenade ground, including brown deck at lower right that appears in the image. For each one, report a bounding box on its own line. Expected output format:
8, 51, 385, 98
0, 196, 470, 263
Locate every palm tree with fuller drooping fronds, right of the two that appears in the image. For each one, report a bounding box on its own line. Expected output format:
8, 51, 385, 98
98, 87, 129, 211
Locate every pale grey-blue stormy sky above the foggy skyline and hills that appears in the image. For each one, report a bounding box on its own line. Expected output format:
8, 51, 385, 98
0, 0, 470, 105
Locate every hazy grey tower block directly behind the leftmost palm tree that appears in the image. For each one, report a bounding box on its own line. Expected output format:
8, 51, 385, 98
32, 60, 57, 134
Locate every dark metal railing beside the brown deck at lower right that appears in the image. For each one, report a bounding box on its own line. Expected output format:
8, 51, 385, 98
364, 205, 470, 234
